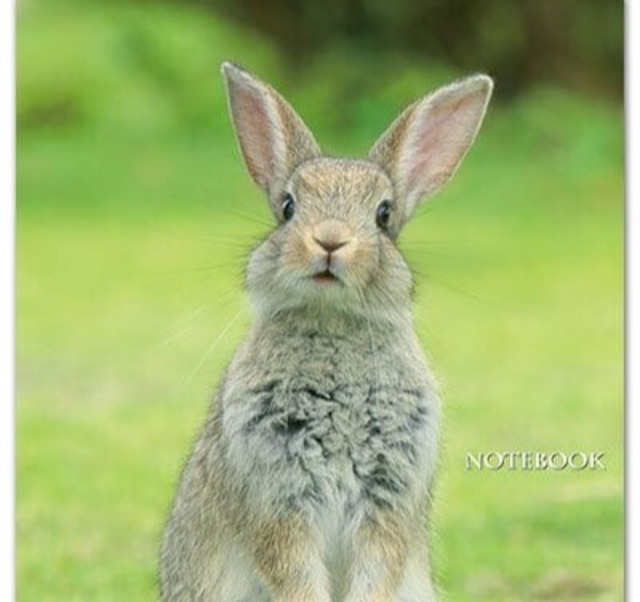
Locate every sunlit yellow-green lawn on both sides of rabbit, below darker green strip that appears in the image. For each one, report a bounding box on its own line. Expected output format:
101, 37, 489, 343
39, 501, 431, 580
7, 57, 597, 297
18, 137, 622, 600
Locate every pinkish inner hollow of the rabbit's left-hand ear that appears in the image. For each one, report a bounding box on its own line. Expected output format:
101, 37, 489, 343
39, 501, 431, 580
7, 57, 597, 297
233, 85, 275, 187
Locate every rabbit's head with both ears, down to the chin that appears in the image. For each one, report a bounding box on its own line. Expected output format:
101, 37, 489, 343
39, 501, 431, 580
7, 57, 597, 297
222, 63, 493, 316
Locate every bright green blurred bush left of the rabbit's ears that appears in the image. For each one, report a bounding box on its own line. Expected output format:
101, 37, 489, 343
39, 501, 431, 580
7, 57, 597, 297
17, 1, 280, 132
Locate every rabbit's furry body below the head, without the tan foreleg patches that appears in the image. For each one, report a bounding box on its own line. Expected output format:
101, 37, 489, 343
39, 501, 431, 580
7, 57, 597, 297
160, 314, 439, 602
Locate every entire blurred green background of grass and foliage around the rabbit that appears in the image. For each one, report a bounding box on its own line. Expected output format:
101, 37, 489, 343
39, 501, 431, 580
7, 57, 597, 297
16, 0, 624, 602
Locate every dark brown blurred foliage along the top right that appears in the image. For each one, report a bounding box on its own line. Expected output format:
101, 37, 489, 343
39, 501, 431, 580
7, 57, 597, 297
189, 0, 624, 98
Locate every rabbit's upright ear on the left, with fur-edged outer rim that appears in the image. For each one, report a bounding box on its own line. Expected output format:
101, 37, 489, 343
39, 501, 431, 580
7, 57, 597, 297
222, 62, 320, 194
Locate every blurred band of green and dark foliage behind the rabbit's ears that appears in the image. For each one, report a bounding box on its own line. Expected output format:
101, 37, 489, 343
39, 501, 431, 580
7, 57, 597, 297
17, 0, 623, 135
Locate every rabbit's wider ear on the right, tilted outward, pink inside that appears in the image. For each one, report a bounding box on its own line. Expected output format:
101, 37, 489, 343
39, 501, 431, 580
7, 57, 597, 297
369, 75, 493, 219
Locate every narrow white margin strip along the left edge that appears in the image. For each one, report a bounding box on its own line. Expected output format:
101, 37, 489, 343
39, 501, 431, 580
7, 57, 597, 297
0, 2, 15, 600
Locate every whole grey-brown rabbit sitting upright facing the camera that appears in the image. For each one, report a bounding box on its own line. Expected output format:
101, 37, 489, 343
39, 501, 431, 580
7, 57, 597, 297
160, 62, 493, 602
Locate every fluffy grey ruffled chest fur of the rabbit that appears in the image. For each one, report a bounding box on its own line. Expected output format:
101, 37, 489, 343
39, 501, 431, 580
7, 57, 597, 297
221, 318, 439, 523
